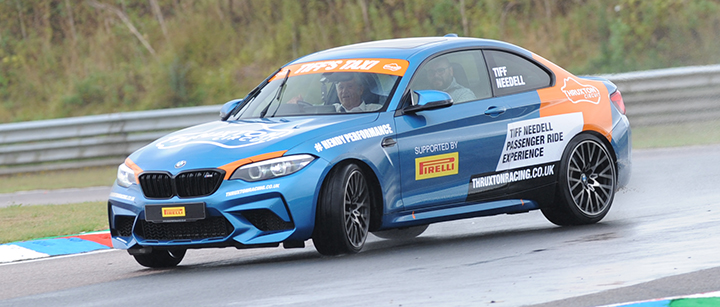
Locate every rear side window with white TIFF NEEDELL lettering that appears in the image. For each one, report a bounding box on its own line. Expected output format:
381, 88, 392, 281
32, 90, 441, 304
483, 50, 552, 96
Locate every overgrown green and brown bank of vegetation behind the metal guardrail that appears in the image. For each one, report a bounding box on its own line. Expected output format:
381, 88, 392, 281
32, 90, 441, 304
0, 0, 720, 123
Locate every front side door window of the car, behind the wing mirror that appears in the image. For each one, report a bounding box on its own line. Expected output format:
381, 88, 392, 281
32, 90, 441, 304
410, 50, 492, 103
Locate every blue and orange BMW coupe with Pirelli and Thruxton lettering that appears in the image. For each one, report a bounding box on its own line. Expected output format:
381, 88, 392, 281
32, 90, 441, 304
108, 35, 631, 267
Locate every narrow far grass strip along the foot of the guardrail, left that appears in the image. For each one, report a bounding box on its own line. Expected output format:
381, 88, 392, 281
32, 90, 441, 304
0, 166, 117, 193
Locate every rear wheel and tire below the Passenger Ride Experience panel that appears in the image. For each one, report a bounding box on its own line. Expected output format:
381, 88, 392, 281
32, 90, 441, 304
542, 134, 617, 226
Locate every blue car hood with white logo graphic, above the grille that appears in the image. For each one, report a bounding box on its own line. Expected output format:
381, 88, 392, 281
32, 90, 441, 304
129, 113, 377, 173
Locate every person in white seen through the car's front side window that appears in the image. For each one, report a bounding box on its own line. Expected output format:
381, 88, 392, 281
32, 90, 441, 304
426, 58, 475, 102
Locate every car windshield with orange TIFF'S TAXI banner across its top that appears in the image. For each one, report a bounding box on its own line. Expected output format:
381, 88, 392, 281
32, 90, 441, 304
232, 59, 408, 120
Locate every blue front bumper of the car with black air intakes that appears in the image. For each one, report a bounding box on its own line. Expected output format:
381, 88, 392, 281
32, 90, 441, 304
108, 159, 327, 249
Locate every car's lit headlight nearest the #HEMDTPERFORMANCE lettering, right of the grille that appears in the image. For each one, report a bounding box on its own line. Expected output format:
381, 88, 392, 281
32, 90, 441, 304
230, 155, 315, 181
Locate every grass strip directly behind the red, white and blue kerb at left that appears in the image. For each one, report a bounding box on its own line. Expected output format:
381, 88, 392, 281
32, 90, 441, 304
0, 202, 108, 244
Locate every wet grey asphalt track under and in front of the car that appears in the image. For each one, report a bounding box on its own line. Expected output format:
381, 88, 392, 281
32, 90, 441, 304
0, 145, 720, 306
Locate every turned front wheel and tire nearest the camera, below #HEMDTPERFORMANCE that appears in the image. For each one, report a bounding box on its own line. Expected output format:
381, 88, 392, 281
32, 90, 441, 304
312, 164, 372, 256
